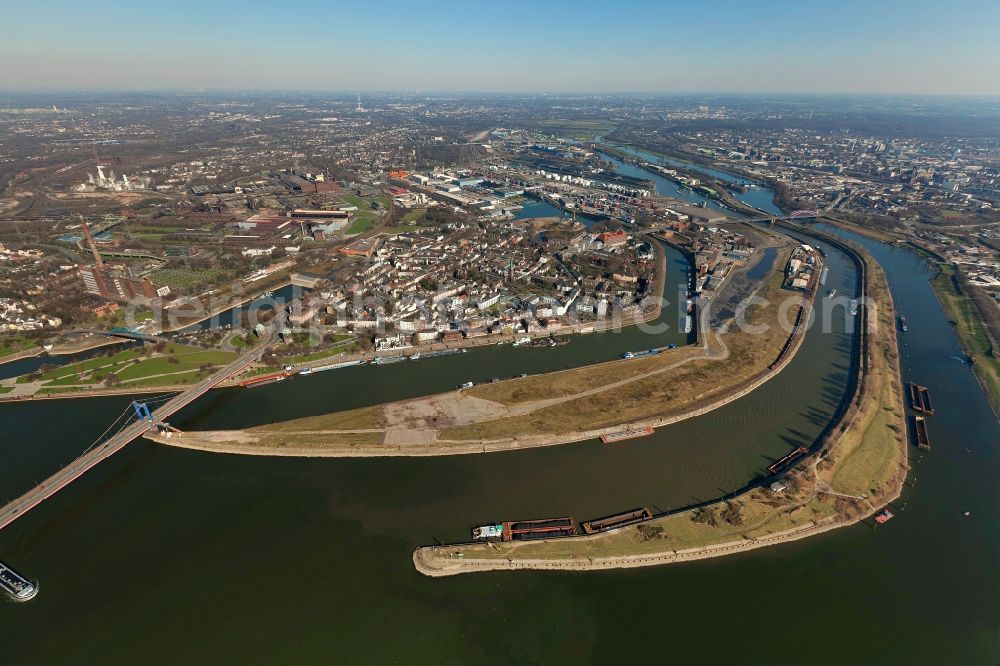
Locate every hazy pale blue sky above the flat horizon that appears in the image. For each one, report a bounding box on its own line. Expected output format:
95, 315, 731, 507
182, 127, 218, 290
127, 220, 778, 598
0, 0, 1000, 94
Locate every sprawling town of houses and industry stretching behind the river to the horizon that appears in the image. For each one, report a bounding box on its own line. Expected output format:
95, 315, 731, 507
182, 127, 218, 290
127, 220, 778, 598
0, 92, 1000, 358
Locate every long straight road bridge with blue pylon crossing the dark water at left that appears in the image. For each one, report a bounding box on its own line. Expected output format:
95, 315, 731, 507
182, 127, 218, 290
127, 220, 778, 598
0, 338, 274, 530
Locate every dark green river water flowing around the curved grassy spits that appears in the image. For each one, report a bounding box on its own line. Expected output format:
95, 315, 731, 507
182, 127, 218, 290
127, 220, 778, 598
0, 170, 1000, 664
